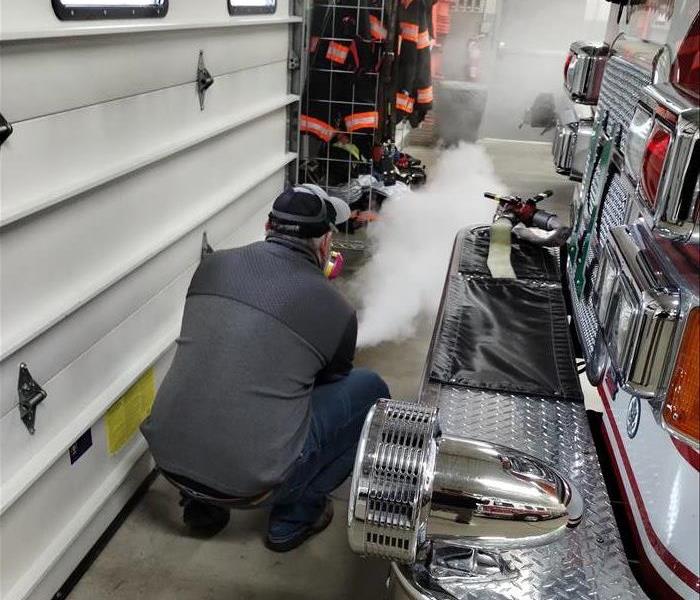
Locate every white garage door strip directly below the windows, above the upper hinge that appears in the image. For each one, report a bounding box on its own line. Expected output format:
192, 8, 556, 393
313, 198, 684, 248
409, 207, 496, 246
0, 24, 288, 124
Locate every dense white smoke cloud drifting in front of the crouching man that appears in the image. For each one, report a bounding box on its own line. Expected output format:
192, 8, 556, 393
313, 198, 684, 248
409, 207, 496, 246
352, 144, 506, 346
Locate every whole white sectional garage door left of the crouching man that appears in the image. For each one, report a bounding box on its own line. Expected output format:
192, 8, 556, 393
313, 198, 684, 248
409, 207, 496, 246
0, 0, 302, 600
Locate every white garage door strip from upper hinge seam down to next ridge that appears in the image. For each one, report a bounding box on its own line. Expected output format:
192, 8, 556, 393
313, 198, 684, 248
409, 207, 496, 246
0, 62, 295, 225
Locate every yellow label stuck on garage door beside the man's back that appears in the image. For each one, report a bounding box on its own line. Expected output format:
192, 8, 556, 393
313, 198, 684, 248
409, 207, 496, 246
105, 368, 156, 454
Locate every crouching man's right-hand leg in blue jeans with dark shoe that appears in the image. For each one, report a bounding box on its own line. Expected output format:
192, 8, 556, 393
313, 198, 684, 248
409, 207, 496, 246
268, 369, 389, 542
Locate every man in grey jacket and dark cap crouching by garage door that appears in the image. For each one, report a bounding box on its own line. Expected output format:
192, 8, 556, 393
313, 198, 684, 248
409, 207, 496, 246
142, 185, 389, 552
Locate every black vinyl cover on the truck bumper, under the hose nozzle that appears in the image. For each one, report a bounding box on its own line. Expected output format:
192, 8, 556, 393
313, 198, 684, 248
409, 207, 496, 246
430, 230, 583, 401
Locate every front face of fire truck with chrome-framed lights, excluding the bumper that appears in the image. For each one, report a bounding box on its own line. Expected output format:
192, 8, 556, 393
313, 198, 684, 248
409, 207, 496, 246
553, 2, 700, 598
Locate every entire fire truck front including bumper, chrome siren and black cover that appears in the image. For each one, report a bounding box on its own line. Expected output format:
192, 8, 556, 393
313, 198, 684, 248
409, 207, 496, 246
348, 0, 700, 600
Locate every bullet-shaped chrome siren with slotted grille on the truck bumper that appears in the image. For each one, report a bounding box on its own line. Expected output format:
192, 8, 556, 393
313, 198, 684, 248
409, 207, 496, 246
348, 400, 583, 563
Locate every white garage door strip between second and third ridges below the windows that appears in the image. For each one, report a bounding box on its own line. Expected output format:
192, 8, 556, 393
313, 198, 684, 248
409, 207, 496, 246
0, 110, 286, 356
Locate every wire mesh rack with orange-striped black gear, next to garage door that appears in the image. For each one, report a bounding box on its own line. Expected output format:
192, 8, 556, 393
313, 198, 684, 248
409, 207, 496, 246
299, 0, 388, 190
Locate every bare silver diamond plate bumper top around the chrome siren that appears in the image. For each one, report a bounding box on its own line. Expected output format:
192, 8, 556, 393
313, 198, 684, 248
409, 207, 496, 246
423, 384, 646, 600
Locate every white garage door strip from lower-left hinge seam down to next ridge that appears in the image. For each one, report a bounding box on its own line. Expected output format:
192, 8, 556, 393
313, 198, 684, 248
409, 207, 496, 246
0, 171, 284, 513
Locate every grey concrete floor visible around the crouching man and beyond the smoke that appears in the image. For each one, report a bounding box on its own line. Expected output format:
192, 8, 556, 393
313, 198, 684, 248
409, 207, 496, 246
70, 140, 573, 600
